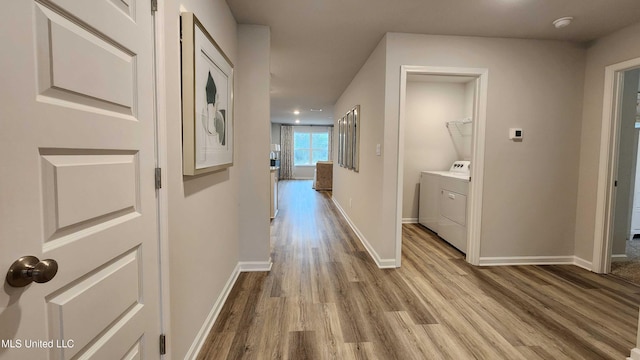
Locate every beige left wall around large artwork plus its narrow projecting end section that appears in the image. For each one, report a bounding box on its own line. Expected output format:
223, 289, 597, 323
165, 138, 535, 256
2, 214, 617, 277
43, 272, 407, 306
161, 0, 269, 359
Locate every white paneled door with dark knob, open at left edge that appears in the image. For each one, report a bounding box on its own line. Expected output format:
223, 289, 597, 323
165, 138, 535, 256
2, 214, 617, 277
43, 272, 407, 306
0, 0, 160, 359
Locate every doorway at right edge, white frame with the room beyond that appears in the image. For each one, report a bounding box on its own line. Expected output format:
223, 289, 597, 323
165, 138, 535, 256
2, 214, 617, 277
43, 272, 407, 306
592, 58, 640, 281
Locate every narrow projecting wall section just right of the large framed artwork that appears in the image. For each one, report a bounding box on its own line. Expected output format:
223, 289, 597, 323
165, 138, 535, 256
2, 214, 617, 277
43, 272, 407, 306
234, 25, 271, 263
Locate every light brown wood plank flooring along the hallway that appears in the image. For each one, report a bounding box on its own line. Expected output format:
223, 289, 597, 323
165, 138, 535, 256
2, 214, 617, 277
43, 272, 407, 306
198, 181, 640, 360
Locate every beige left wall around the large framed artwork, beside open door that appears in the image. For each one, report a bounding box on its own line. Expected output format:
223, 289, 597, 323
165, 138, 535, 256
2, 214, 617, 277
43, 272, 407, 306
160, 0, 239, 359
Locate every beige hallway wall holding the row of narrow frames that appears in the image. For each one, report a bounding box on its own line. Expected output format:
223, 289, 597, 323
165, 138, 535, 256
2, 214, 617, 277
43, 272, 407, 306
333, 38, 394, 259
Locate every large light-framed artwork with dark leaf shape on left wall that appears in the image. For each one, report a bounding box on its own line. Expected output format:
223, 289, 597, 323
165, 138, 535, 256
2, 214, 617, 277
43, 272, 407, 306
181, 12, 233, 175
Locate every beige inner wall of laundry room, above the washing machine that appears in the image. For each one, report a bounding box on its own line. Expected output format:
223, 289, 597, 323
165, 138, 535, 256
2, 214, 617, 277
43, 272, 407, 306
402, 81, 462, 222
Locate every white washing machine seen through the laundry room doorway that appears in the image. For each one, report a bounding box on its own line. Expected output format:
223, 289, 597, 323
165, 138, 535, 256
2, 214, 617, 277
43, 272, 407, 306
418, 161, 471, 253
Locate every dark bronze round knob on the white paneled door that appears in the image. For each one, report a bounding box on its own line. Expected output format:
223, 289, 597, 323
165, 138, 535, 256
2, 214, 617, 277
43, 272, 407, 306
7, 256, 58, 287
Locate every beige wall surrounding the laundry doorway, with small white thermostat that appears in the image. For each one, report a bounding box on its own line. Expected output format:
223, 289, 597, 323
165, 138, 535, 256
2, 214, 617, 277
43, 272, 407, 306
380, 33, 585, 257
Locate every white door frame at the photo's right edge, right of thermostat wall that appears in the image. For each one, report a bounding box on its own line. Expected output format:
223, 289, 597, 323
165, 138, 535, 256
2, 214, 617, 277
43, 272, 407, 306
591, 58, 640, 274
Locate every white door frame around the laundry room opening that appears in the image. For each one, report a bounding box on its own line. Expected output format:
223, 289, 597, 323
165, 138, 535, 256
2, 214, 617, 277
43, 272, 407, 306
396, 65, 489, 267
